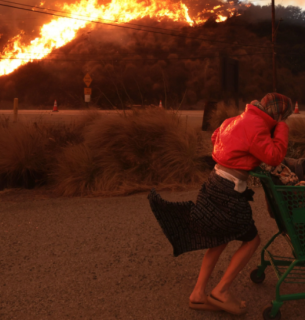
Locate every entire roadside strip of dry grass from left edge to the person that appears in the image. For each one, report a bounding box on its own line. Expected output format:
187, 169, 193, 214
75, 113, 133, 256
0, 109, 209, 196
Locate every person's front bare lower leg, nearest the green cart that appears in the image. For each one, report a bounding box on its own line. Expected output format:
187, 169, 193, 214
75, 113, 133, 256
211, 235, 260, 302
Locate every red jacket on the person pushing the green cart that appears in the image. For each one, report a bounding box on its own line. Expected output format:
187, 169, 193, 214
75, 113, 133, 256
212, 104, 289, 171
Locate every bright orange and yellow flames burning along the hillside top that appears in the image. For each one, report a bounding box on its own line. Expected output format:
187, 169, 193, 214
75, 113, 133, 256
0, 0, 238, 76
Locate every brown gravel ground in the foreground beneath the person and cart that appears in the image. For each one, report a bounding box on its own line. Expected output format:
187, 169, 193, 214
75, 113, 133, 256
0, 187, 304, 320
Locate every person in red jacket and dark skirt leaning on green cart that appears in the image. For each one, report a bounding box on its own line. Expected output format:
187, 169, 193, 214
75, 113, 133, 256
148, 93, 293, 315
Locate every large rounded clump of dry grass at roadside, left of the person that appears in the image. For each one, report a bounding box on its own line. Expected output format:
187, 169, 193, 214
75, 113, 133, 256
53, 109, 210, 196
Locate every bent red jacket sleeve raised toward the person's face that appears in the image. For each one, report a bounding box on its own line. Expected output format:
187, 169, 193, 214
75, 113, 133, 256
249, 122, 289, 167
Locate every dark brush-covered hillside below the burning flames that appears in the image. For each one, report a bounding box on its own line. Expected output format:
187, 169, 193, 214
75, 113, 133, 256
0, 2, 305, 109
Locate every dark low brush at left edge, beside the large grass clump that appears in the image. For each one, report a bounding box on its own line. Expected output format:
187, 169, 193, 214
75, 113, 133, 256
0, 111, 97, 190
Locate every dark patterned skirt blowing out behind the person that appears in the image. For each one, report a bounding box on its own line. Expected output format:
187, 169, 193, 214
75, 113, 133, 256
148, 170, 257, 256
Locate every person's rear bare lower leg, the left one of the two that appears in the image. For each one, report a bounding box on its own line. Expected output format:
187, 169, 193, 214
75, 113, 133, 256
190, 244, 227, 303
